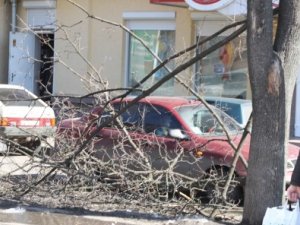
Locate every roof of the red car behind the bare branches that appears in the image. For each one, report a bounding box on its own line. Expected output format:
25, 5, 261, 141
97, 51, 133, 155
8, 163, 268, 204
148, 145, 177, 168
115, 96, 202, 109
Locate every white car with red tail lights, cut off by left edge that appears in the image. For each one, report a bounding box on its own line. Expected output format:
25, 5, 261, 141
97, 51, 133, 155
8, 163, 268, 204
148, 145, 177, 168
0, 84, 56, 154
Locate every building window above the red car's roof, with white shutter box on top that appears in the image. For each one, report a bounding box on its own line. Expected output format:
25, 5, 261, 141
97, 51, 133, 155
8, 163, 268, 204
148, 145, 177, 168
126, 12, 175, 95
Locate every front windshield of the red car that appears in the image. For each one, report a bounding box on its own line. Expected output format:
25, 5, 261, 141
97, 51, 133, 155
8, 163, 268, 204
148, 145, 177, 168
176, 105, 241, 135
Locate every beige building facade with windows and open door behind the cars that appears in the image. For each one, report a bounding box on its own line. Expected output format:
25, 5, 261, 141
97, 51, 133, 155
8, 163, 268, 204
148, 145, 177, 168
0, 0, 300, 136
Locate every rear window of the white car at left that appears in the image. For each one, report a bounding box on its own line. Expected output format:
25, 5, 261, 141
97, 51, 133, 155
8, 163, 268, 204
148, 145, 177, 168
0, 88, 44, 106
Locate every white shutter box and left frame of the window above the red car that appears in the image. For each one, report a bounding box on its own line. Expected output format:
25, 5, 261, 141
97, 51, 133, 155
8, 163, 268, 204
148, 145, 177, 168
123, 11, 176, 87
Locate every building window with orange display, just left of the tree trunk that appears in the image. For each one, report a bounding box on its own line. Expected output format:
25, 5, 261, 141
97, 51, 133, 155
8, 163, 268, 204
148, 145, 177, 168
194, 21, 250, 99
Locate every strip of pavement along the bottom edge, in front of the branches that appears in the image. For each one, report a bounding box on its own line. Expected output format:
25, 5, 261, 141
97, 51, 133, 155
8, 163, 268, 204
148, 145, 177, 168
0, 208, 227, 225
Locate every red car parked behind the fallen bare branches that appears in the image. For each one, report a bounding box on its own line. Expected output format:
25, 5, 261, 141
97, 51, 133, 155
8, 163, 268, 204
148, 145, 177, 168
58, 97, 299, 202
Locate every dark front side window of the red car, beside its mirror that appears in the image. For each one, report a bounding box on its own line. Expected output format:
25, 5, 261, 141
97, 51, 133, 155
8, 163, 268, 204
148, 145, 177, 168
144, 105, 182, 133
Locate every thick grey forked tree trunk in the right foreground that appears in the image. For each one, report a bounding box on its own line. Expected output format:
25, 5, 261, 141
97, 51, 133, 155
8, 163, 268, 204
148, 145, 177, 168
243, 0, 300, 225
